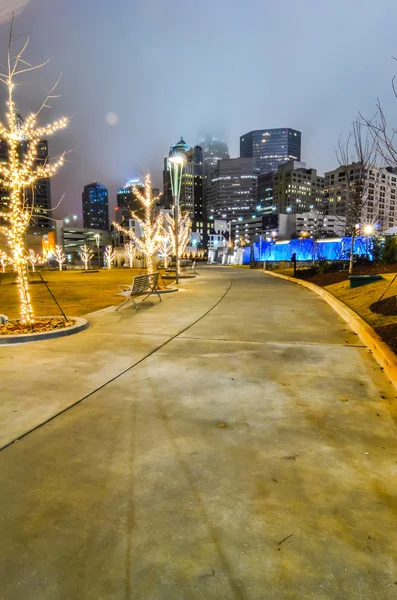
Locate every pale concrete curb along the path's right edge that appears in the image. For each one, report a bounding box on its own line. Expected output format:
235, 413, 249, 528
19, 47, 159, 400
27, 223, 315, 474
263, 269, 397, 390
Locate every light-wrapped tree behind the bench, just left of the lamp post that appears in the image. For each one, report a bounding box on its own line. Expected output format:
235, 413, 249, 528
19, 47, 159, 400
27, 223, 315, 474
113, 173, 162, 273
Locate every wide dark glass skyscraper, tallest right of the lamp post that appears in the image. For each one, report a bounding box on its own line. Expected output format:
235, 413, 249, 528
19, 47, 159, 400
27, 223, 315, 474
240, 127, 301, 173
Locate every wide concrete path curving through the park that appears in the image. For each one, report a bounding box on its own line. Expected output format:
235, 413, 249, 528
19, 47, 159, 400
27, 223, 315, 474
0, 268, 397, 600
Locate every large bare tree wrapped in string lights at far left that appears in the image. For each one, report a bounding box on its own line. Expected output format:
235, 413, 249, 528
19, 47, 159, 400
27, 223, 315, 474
0, 19, 68, 327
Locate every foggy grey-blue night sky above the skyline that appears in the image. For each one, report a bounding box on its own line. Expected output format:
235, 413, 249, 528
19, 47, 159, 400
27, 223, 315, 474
0, 0, 397, 223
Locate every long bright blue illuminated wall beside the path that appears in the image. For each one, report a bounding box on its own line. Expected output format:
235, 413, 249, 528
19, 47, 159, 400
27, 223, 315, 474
243, 237, 372, 265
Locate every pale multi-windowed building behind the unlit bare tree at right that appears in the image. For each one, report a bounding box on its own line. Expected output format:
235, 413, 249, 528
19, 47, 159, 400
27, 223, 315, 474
323, 163, 397, 233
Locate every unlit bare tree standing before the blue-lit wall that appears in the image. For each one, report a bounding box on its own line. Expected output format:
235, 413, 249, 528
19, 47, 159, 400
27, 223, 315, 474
336, 119, 377, 275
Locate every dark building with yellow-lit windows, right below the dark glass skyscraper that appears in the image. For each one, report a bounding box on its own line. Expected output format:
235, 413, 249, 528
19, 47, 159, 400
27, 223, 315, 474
267, 160, 324, 214
